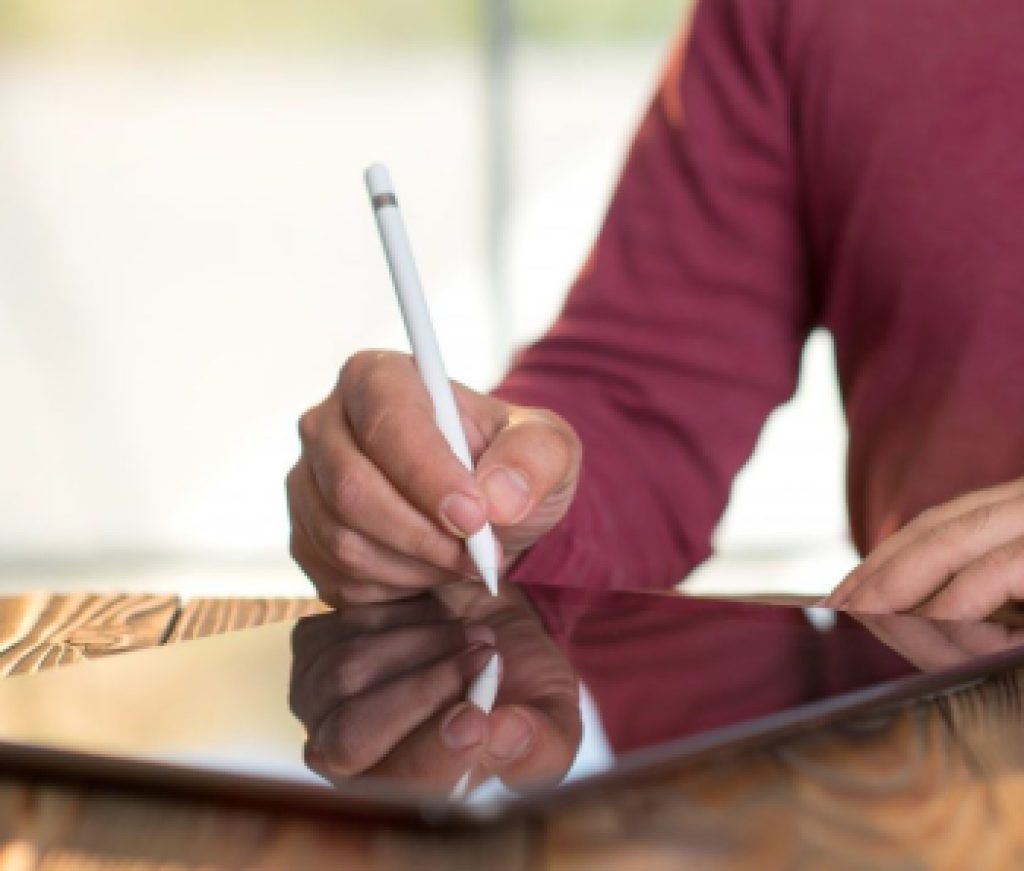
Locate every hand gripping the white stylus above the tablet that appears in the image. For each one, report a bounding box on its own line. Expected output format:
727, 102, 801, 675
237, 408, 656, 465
288, 351, 581, 606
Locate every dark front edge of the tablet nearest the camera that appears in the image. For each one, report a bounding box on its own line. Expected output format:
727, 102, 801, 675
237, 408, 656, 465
0, 618, 1024, 827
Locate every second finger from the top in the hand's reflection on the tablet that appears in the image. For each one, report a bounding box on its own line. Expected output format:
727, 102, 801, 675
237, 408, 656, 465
289, 620, 495, 732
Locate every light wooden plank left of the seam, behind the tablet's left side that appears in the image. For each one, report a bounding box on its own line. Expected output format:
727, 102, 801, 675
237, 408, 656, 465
0, 593, 178, 676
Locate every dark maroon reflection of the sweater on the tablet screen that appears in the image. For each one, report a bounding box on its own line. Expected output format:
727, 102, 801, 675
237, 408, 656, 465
527, 585, 916, 752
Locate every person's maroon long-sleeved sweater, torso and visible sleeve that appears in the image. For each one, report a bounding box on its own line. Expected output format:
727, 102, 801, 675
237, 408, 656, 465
499, 0, 1024, 586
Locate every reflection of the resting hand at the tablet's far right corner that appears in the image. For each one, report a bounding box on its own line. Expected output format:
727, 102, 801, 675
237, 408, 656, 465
854, 614, 1024, 671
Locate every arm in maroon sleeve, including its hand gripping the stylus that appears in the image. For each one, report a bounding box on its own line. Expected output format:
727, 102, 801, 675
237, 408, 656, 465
288, 0, 813, 606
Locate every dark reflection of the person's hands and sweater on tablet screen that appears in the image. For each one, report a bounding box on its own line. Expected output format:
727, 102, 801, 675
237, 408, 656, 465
290, 584, 1024, 795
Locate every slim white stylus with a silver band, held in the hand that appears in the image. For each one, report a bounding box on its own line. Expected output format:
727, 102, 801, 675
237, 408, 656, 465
366, 164, 498, 596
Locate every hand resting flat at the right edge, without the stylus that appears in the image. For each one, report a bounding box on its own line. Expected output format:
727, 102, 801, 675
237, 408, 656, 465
821, 480, 1024, 620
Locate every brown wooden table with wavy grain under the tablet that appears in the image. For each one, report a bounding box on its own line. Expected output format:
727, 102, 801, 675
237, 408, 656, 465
0, 594, 1024, 871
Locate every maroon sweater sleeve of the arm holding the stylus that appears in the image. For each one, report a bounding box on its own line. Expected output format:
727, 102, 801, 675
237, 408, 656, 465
496, 0, 814, 587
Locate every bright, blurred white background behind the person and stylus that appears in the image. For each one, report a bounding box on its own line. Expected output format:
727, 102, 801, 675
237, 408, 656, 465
0, 0, 852, 596
